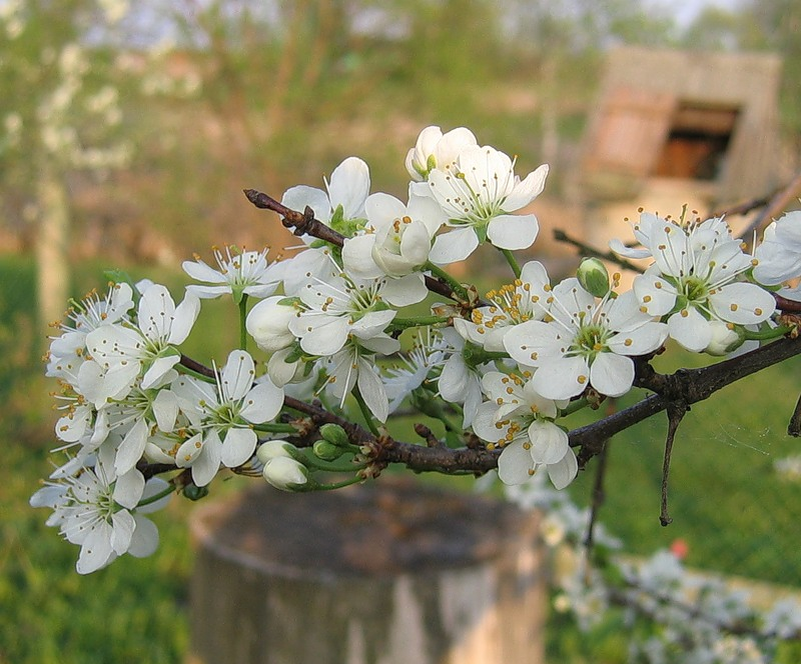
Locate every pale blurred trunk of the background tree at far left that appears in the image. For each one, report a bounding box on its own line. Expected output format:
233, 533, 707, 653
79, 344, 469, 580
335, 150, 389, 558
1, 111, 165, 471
36, 165, 70, 325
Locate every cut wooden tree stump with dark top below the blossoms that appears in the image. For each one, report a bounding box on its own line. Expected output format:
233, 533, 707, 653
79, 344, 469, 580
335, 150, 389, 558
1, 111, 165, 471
189, 478, 545, 664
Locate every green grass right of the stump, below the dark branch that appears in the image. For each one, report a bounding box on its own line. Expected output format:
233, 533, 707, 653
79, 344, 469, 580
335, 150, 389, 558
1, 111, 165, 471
571, 355, 801, 586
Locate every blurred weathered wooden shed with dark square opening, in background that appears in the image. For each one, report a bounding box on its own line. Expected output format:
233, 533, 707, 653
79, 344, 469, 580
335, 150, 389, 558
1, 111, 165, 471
581, 47, 781, 214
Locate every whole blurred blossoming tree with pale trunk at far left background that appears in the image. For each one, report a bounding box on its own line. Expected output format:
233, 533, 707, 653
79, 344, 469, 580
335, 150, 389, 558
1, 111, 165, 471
0, 0, 131, 322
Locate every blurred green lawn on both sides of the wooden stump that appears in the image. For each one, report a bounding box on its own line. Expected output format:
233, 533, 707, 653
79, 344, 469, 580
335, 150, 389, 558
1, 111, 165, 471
0, 253, 801, 664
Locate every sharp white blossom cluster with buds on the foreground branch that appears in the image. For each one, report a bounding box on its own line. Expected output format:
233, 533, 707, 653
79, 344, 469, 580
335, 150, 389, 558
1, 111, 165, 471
32, 127, 801, 596
